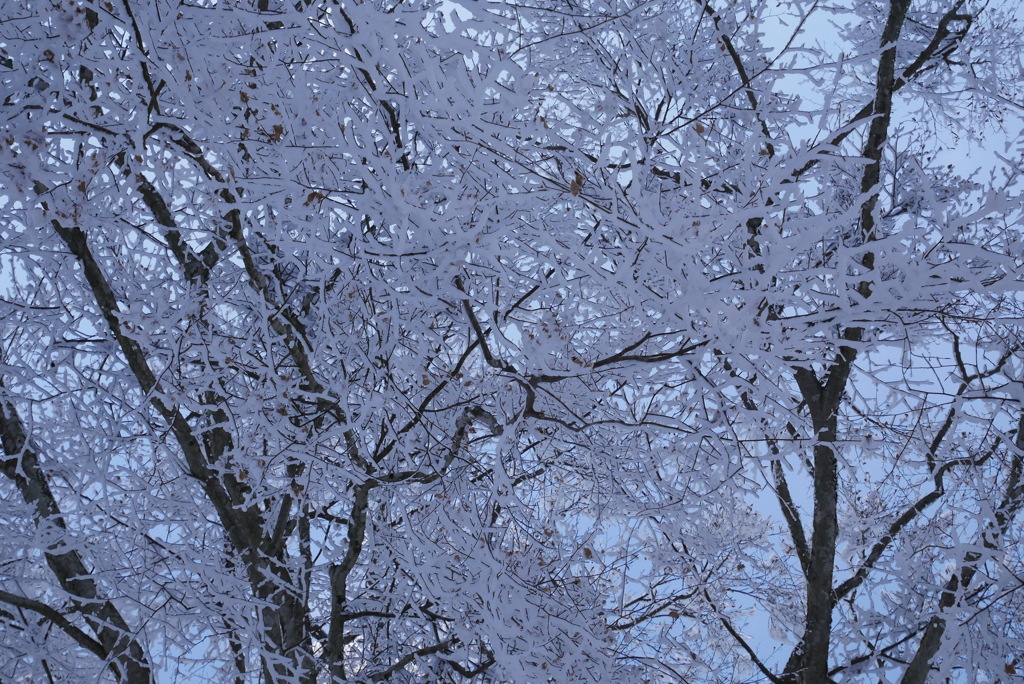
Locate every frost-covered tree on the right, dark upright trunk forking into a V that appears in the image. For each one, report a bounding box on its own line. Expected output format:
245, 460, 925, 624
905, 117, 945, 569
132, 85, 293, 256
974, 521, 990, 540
520, 1, 1024, 682
